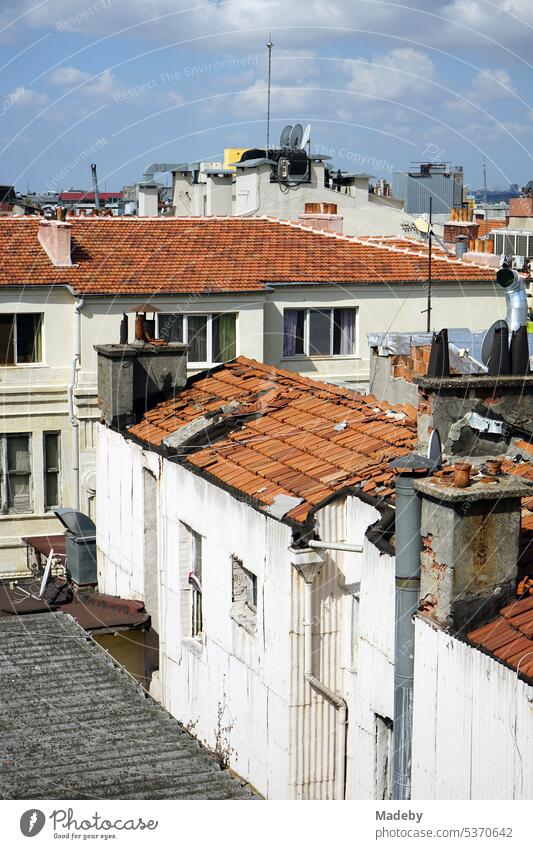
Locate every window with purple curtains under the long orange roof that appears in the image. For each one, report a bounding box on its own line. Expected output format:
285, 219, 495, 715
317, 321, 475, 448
283, 307, 357, 357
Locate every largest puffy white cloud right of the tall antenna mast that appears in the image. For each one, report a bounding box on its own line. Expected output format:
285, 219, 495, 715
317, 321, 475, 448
344, 47, 435, 100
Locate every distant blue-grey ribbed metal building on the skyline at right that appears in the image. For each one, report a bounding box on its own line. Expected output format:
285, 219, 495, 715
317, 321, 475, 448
393, 162, 463, 216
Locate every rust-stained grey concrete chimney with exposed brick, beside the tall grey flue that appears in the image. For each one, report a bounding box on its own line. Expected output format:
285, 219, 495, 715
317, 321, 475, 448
414, 473, 531, 633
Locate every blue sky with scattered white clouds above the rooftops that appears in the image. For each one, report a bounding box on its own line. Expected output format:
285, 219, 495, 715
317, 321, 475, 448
0, 0, 533, 190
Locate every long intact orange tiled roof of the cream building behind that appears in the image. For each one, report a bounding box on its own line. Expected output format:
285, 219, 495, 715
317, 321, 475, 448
0, 217, 493, 295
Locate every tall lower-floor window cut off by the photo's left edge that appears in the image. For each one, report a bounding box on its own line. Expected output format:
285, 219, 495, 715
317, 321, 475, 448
0, 433, 32, 513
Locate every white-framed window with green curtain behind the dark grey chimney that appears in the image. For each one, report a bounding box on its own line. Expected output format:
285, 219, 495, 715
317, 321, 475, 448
159, 313, 237, 364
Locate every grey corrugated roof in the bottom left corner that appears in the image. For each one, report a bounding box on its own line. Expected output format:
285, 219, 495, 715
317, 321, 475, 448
0, 613, 252, 799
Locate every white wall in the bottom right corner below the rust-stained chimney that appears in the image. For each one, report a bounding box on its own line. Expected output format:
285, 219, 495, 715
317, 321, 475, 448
412, 617, 533, 799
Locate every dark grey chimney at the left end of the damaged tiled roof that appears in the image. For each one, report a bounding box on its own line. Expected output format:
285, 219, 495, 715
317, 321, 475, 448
94, 339, 187, 430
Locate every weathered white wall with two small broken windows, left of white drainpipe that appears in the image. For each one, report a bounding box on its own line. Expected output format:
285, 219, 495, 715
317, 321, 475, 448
97, 425, 292, 799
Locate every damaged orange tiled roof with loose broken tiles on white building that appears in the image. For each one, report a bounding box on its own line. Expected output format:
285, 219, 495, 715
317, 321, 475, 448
129, 357, 416, 522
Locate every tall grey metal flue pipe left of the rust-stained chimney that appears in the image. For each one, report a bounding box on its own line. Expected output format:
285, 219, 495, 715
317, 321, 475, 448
390, 455, 429, 800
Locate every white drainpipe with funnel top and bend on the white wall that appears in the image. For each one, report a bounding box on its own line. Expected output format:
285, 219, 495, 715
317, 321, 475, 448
290, 544, 348, 799
